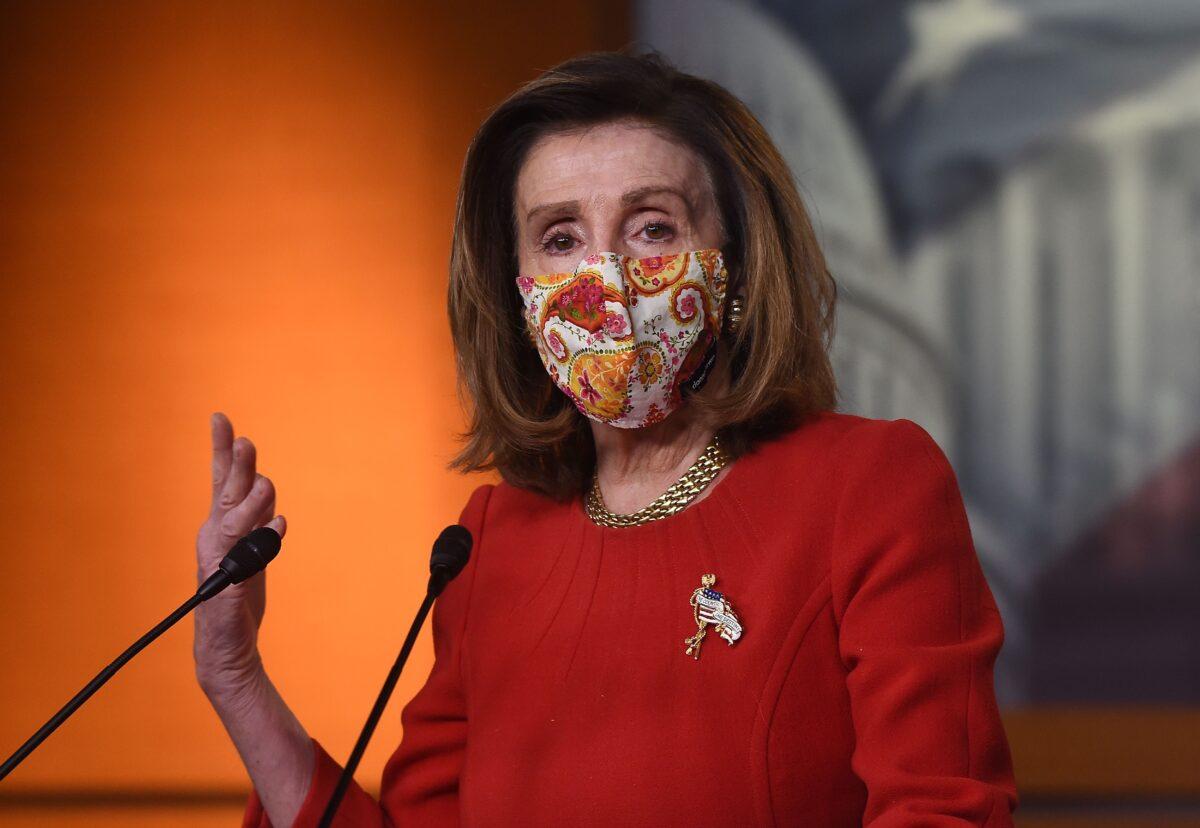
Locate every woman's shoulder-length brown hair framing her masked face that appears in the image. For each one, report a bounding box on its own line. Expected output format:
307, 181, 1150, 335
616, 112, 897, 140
449, 49, 838, 499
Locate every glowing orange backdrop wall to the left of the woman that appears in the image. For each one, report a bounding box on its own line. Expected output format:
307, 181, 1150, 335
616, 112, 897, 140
0, 0, 625, 824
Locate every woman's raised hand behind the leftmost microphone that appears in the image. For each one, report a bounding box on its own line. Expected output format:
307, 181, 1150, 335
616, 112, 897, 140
194, 413, 287, 697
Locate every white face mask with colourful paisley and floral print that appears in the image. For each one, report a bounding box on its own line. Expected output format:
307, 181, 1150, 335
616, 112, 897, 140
517, 248, 728, 428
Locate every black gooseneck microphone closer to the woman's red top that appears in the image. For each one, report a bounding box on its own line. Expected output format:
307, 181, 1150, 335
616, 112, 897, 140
319, 523, 473, 828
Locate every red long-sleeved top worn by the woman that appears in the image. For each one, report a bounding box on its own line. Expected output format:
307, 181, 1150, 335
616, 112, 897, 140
244, 412, 1018, 828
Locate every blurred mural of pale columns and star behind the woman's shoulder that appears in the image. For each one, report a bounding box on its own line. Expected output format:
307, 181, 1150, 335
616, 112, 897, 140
635, 0, 1200, 704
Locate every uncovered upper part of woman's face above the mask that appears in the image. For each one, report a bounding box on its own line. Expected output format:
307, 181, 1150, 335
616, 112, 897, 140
515, 121, 724, 276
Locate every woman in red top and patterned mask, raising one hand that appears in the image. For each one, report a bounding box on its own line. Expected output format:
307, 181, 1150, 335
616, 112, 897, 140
196, 53, 1016, 826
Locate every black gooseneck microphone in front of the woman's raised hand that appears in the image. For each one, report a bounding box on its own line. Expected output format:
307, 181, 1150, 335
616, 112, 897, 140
0, 526, 283, 780
